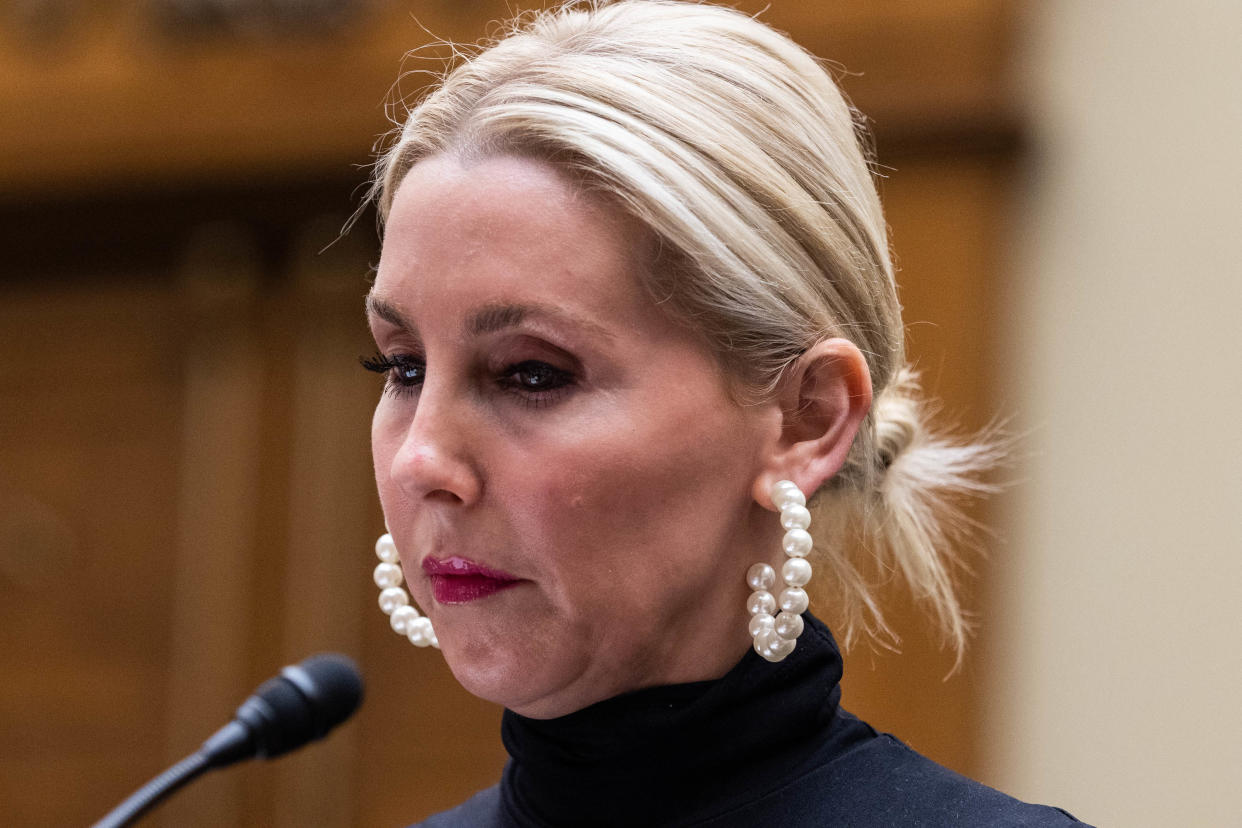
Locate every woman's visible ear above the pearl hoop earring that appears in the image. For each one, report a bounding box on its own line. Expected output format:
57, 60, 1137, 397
753, 338, 872, 509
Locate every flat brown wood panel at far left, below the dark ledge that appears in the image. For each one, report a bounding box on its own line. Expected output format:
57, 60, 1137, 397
0, 283, 180, 826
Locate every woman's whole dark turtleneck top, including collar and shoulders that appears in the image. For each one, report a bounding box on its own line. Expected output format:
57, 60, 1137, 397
409, 613, 1082, 828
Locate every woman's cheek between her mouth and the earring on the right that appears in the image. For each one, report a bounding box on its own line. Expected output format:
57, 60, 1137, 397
499, 394, 753, 607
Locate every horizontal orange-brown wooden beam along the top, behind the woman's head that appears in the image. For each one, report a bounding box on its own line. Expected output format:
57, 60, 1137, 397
0, 0, 1013, 197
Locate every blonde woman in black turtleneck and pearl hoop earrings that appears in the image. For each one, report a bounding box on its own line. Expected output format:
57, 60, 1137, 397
365, 0, 1073, 826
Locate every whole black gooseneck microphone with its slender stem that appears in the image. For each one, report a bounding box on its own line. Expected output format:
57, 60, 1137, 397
93, 653, 363, 828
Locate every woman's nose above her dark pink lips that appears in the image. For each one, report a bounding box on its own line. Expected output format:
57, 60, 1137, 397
390, 382, 482, 505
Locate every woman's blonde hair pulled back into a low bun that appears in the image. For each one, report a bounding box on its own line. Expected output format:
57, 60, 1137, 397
373, 0, 990, 657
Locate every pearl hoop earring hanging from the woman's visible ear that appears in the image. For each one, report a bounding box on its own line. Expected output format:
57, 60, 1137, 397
746, 480, 814, 662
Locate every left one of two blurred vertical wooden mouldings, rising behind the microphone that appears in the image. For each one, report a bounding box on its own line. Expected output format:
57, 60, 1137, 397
160, 223, 266, 826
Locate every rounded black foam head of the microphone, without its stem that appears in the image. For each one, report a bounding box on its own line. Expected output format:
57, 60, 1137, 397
236, 653, 363, 758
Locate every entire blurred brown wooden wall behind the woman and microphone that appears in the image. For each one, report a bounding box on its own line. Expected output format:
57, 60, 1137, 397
0, 0, 1023, 826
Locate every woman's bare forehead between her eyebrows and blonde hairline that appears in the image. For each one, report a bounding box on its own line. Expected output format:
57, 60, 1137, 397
373, 155, 653, 325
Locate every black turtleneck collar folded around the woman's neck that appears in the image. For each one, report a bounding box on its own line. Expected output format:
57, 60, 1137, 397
501, 613, 856, 826
